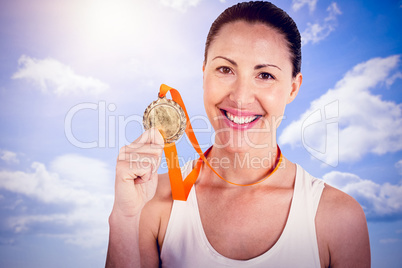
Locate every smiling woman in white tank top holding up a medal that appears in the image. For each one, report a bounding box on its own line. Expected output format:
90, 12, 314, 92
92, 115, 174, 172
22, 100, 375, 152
107, 2, 370, 267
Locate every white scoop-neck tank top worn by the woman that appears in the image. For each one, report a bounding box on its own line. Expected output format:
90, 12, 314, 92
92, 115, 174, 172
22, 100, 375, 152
161, 161, 324, 268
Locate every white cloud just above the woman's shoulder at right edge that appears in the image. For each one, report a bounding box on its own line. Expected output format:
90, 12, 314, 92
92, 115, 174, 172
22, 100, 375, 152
323, 171, 402, 220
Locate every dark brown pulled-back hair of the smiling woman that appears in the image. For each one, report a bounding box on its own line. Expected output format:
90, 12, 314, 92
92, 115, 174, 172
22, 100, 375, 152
204, 1, 301, 77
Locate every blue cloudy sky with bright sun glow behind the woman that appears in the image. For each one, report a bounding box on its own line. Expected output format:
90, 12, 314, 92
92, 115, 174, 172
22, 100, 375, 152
0, 0, 402, 267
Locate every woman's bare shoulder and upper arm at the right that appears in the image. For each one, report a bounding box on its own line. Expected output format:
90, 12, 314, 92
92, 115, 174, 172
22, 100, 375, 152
316, 184, 370, 267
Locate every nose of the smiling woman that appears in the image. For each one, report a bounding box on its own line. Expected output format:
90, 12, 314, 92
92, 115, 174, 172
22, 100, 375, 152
229, 78, 255, 108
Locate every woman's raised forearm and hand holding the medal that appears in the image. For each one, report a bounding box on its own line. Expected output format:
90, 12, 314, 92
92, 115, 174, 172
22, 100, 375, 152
106, 129, 164, 268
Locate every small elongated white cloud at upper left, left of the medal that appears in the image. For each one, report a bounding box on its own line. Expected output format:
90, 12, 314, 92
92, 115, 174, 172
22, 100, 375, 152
11, 55, 108, 96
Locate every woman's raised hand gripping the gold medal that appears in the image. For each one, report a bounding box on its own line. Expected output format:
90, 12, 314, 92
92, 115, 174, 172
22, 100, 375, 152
113, 128, 164, 216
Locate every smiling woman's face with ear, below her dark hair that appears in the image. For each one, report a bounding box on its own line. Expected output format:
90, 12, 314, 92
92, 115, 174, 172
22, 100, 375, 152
203, 21, 302, 152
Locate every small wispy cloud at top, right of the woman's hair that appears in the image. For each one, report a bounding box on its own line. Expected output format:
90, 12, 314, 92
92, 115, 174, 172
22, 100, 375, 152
301, 2, 342, 45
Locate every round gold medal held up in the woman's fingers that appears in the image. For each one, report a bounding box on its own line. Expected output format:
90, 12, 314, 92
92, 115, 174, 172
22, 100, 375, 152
143, 96, 187, 143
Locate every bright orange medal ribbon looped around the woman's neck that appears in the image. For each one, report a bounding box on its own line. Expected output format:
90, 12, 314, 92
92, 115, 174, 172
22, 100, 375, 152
159, 84, 282, 201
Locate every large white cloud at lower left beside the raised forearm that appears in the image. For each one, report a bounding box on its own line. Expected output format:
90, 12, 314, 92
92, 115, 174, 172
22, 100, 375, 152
0, 155, 113, 247
